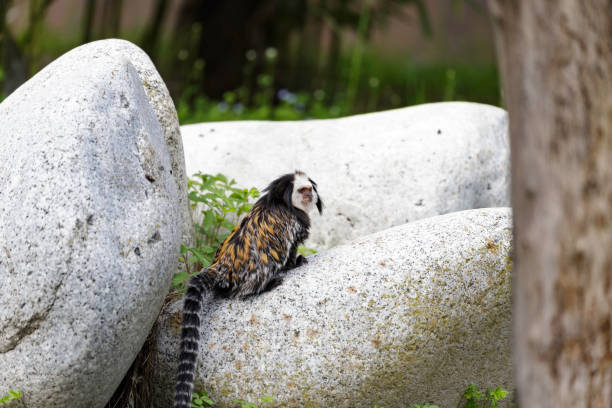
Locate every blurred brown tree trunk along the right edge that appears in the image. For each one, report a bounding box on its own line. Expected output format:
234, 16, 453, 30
489, 0, 612, 408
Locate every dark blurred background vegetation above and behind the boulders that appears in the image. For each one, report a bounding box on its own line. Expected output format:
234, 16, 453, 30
0, 0, 500, 124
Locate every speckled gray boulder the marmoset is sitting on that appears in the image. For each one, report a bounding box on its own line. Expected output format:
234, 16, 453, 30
155, 208, 513, 408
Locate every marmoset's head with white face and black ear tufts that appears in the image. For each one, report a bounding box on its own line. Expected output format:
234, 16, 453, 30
264, 170, 323, 214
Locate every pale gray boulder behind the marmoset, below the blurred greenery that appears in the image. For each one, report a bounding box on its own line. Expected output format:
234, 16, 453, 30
181, 102, 510, 249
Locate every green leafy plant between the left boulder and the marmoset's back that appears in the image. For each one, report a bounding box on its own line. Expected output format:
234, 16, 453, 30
172, 173, 259, 289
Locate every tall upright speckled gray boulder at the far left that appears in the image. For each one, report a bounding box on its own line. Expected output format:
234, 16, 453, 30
0, 41, 182, 408
